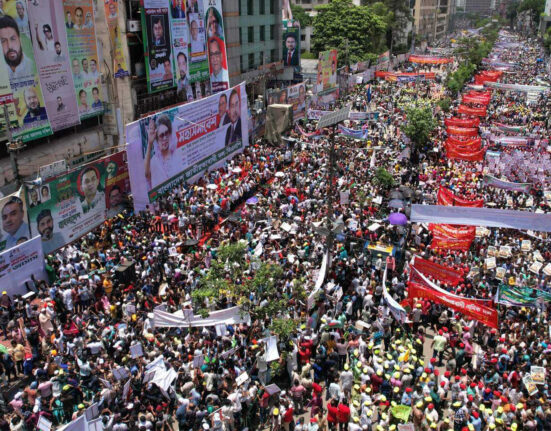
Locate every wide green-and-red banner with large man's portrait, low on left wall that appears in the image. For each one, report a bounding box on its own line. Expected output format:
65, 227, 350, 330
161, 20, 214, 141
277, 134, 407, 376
27, 152, 130, 254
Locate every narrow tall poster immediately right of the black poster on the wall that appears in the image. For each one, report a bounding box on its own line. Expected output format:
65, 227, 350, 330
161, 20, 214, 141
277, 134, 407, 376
170, 0, 194, 102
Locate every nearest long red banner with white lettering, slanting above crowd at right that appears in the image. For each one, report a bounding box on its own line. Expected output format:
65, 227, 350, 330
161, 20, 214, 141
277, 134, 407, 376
408, 282, 498, 329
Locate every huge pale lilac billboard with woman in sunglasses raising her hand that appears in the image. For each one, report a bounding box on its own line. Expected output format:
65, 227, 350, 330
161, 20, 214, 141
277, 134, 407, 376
126, 83, 249, 211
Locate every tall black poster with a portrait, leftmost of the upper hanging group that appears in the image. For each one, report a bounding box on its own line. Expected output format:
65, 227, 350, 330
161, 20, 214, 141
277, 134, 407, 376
141, 0, 175, 93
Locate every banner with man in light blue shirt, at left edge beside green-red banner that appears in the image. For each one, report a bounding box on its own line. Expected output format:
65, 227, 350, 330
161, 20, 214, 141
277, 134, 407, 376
0, 189, 31, 251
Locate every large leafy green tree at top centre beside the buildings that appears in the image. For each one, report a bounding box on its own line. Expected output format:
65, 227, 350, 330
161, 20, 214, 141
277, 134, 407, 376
312, 0, 392, 65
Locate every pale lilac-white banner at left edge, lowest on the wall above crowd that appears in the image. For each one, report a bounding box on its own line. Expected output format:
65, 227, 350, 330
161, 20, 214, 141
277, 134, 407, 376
0, 236, 47, 297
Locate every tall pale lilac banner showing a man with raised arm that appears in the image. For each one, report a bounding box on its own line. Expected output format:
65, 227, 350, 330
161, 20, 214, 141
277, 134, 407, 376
27, 1, 80, 132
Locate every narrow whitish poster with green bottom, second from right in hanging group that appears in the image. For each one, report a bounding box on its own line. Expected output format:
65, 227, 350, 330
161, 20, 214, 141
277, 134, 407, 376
187, 0, 209, 84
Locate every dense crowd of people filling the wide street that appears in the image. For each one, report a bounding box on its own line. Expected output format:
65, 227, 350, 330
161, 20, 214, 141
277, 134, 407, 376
0, 27, 551, 431
